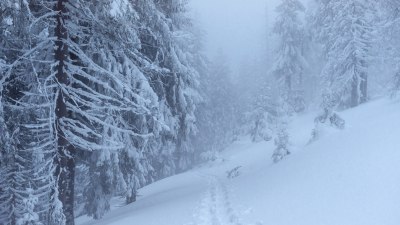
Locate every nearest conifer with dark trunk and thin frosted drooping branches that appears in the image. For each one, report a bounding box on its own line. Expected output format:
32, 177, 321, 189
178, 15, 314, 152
1, 0, 161, 224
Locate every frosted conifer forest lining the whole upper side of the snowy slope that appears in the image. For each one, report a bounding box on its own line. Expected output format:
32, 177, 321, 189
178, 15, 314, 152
0, 0, 400, 225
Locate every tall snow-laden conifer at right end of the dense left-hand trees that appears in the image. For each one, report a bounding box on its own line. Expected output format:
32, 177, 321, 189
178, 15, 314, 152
136, 0, 202, 174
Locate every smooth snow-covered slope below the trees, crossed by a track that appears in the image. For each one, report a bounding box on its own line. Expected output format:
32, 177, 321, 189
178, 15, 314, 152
78, 100, 400, 225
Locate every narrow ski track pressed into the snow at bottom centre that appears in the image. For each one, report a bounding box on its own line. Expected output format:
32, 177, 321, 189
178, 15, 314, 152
190, 175, 243, 225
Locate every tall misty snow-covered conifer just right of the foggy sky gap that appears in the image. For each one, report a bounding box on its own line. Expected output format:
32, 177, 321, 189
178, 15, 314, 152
272, 0, 307, 112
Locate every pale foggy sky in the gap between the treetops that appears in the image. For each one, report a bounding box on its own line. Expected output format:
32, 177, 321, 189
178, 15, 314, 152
191, 0, 277, 69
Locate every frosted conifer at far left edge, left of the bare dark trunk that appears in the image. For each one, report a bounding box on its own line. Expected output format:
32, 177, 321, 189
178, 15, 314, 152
0, 1, 61, 224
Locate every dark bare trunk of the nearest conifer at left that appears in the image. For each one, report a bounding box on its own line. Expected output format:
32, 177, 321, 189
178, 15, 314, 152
54, 0, 75, 225
